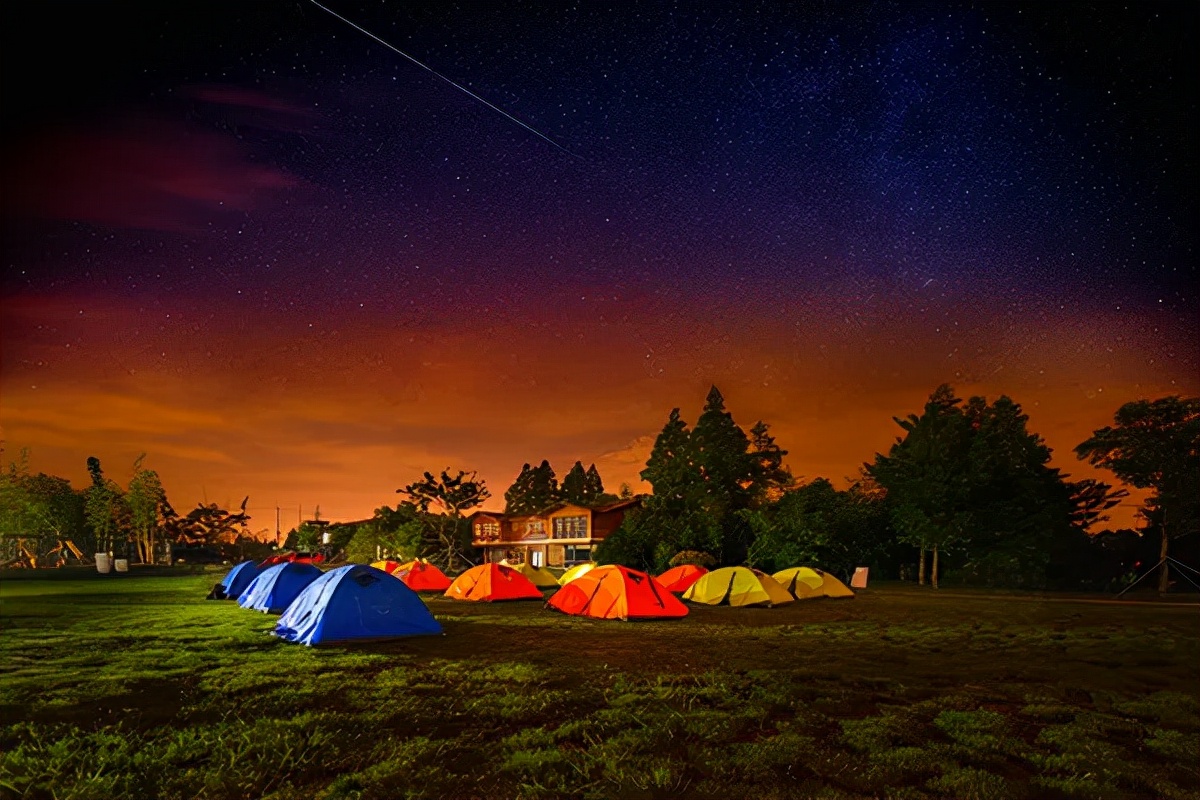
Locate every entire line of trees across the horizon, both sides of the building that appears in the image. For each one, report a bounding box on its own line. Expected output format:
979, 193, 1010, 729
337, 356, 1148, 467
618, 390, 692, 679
0, 385, 1200, 590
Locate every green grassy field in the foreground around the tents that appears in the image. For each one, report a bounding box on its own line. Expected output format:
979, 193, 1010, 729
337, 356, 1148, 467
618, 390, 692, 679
0, 572, 1200, 800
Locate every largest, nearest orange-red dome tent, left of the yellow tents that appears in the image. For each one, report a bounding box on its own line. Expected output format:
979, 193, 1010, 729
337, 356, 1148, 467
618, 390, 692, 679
547, 565, 688, 619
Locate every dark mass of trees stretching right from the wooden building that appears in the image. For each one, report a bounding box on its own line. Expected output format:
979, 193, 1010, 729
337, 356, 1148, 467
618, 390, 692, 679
596, 385, 1200, 590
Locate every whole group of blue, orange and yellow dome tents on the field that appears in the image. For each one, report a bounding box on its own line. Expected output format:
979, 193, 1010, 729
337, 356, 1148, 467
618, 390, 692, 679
209, 560, 854, 645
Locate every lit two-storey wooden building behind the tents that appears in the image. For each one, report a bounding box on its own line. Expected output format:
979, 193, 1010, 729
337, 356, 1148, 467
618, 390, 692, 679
467, 498, 642, 567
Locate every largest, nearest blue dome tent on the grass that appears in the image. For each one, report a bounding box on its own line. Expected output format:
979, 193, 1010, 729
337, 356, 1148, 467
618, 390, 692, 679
275, 564, 442, 644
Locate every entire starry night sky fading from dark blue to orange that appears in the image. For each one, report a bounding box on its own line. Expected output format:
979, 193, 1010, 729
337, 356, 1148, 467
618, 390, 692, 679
0, 0, 1200, 533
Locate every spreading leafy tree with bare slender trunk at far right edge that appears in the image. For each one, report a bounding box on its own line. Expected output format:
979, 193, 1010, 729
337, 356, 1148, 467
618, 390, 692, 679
1075, 396, 1200, 593
